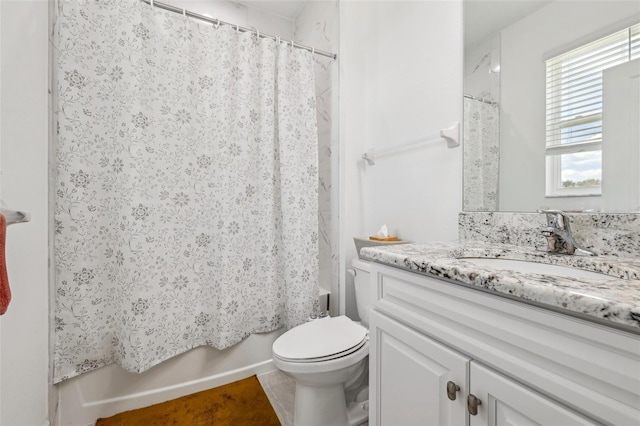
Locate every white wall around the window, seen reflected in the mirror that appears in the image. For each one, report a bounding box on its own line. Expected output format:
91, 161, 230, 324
499, 0, 640, 211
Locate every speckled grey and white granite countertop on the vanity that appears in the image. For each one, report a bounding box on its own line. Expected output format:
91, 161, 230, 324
360, 241, 640, 334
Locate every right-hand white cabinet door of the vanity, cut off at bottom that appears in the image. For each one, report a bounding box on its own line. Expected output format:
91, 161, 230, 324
468, 361, 598, 426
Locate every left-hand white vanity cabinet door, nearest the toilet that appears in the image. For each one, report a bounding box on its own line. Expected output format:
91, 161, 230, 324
369, 311, 469, 426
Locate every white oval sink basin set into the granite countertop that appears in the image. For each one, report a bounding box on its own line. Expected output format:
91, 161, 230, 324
460, 257, 615, 281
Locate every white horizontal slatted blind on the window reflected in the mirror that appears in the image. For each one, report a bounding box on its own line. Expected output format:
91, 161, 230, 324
546, 24, 640, 151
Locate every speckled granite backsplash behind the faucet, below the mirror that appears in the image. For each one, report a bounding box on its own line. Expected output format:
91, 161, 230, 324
458, 212, 640, 257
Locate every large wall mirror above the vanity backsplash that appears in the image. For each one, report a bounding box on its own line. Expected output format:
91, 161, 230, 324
463, 0, 640, 213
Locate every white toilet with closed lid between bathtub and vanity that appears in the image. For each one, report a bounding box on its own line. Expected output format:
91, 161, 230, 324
272, 259, 371, 426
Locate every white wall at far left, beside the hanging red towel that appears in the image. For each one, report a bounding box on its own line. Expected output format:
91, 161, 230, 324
0, 0, 49, 426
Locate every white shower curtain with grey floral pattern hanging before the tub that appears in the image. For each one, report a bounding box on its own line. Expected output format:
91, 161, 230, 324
53, 0, 318, 383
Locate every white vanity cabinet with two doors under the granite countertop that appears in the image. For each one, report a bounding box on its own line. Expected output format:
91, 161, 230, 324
369, 264, 640, 426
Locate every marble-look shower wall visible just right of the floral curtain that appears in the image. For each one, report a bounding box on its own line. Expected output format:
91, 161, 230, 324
294, 1, 339, 302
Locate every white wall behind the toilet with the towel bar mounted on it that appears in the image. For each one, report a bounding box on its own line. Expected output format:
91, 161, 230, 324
340, 1, 463, 313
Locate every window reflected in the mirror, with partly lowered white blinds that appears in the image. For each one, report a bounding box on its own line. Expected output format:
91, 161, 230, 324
545, 24, 640, 197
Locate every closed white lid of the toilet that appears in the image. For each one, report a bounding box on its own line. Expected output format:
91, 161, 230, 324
273, 315, 367, 361
